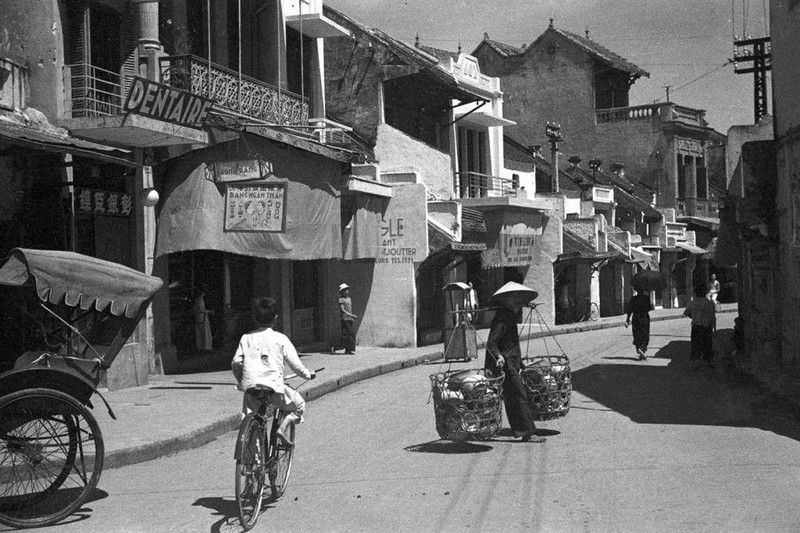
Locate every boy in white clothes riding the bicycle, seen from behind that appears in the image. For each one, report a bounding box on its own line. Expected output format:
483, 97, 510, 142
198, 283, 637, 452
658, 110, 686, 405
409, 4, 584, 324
231, 296, 315, 445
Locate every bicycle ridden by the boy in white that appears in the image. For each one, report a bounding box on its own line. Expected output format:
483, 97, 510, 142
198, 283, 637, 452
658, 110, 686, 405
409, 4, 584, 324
234, 368, 324, 531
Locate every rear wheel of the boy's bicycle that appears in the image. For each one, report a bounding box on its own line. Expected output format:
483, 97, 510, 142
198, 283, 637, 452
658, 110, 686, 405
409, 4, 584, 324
236, 414, 265, 530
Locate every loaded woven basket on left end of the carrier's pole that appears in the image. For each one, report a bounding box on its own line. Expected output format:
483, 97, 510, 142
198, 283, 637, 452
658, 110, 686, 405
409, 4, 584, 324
430, 369, 505, 441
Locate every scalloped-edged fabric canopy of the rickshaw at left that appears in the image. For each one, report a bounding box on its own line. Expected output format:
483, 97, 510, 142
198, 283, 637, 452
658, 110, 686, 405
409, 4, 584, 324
0, 248, 162, 318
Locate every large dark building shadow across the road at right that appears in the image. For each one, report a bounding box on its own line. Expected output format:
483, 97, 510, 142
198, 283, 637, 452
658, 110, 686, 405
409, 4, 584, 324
572, 330, 800, 440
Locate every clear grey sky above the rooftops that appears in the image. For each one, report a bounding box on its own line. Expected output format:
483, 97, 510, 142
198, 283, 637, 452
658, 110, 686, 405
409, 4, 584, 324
325, 0, 772, 133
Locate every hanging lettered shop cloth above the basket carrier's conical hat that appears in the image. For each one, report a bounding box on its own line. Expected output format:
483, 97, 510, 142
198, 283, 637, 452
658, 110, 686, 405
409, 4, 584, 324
481, 211, 544, 268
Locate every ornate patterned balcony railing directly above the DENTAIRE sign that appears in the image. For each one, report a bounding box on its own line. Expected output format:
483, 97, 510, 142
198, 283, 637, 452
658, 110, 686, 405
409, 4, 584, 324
161, 55, 309, 126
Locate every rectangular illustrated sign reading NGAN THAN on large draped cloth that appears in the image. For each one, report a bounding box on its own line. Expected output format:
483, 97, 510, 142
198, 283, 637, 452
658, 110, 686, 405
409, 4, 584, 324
225, 183, 286, 233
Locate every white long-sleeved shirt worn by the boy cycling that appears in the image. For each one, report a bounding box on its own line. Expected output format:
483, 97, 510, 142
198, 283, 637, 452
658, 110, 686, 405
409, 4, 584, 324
233, 328, 311, 394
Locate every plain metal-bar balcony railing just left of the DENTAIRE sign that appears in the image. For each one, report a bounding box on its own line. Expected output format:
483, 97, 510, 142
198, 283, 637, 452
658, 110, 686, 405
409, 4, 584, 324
63, 63, 127, 118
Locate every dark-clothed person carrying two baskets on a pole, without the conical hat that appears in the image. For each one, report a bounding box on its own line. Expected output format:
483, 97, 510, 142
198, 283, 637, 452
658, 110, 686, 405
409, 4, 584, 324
483, 290, 546, 442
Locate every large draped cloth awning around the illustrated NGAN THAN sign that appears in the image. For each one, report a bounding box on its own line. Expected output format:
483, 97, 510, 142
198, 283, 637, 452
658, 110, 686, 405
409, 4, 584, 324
156, 137, 342, 260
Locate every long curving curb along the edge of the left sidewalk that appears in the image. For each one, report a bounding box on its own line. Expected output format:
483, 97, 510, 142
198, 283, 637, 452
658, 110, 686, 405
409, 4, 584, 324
103, 309, 738, 468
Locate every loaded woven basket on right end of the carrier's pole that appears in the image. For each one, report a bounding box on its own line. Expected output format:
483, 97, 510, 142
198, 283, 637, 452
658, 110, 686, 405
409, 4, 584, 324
522, 355, 572, 420
